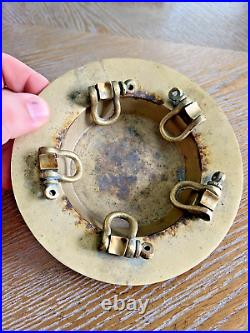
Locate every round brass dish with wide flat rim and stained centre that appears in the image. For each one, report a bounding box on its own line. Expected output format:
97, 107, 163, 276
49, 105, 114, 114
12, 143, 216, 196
12, 59, 242, 285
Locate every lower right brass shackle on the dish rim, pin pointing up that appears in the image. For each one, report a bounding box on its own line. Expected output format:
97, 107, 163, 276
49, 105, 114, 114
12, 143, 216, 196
170, 171, 226, 221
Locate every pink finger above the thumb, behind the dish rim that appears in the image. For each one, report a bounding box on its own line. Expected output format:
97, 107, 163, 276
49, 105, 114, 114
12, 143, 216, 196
2, 53, 49, 94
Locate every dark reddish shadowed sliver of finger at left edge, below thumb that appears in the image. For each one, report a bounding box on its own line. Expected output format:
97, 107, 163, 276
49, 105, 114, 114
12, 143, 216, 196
2, 140, 14, 190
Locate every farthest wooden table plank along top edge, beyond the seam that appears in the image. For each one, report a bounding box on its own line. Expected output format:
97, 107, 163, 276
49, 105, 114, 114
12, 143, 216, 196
3, 2, 247, 51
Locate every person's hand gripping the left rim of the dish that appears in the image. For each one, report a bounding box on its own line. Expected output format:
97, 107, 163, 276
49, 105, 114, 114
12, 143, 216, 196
2, 53, 49, 189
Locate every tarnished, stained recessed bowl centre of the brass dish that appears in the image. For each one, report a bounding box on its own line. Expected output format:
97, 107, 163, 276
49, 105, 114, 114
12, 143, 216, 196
60, 98, 201, 237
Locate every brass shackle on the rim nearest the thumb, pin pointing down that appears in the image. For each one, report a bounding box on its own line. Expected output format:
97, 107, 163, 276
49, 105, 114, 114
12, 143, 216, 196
38, 147, 82, 200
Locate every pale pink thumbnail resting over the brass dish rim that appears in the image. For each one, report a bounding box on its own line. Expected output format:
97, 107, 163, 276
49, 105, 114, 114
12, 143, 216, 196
27, 98, 49, 125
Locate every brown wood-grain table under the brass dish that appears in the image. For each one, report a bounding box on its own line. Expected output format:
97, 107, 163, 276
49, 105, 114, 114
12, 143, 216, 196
3, 3, 247, 330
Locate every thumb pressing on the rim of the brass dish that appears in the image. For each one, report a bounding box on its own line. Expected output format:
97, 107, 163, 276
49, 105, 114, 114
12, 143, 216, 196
2, 89, 49, 143
